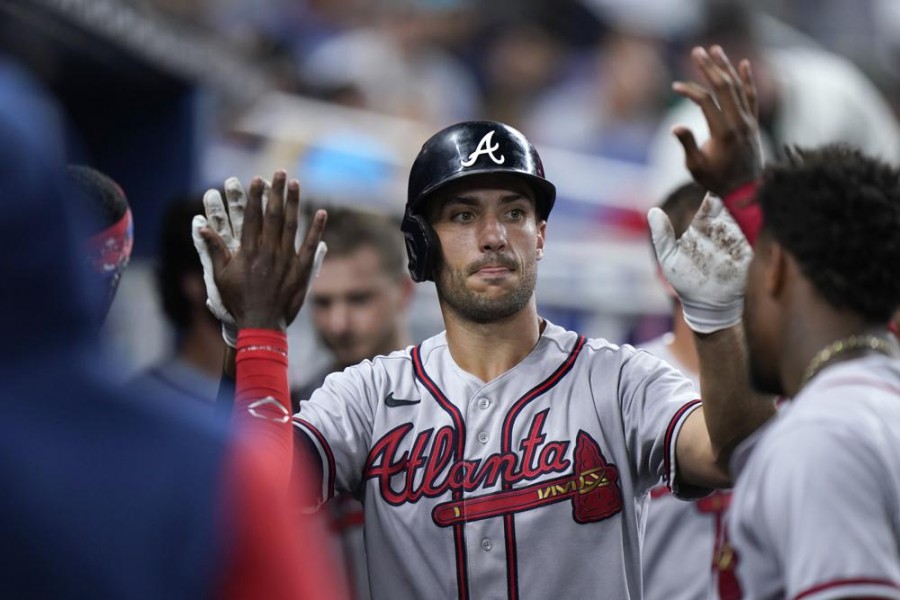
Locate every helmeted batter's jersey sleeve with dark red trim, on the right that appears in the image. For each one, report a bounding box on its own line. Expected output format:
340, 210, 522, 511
604, 346, 710, 498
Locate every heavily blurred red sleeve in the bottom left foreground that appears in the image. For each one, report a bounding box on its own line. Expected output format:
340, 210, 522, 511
219, 439, 349, 600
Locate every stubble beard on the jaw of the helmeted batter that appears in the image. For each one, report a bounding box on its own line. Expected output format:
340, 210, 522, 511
435, 255, 537, 324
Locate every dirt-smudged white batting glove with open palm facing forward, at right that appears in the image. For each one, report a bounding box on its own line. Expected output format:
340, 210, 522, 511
647, 194, 753, 333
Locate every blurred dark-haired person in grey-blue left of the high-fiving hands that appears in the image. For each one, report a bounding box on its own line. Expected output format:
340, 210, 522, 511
135, 198, 225, 405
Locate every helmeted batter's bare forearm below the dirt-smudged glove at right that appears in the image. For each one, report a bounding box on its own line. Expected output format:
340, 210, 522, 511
694, 325, 775, 473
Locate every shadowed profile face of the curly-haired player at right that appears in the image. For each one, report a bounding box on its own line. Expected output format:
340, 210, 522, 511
744, 237, 784, 396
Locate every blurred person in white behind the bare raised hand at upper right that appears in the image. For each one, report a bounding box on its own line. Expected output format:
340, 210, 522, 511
651, 2, 900, 202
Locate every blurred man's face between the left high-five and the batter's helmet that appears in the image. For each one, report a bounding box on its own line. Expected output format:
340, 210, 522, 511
309, 246, 411, 367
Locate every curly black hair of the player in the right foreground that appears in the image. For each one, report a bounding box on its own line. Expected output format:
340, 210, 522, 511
757, 144, 900, 324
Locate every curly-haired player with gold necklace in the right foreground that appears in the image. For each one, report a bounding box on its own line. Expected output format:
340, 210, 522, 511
664, 44, 900, 599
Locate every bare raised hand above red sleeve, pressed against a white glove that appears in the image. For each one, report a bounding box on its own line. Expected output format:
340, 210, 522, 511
199, 171, 326, 331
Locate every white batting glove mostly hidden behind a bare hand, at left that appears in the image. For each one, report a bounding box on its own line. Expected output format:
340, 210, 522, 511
191, 177, 328, 348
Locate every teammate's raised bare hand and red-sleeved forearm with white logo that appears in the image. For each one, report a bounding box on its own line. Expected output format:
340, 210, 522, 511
200, 171, 326, 483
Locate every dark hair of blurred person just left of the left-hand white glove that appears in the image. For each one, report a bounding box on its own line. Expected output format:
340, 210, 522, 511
156, 196, 204, 331
